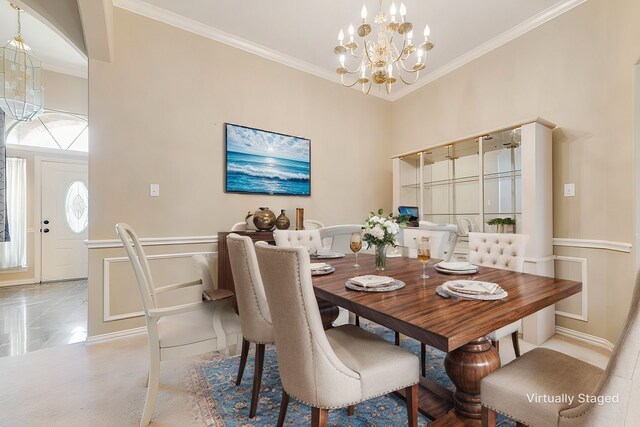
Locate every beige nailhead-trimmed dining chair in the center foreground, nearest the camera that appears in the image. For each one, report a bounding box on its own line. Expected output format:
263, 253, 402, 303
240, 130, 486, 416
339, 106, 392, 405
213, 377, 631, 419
256, 242, 418, 426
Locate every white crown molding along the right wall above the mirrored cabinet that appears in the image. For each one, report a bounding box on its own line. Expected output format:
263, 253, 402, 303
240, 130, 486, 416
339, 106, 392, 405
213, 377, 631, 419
390, 0, 587, 101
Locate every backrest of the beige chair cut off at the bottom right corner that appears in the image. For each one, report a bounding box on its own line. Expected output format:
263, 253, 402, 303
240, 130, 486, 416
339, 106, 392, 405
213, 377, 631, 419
559, 272, 640, 426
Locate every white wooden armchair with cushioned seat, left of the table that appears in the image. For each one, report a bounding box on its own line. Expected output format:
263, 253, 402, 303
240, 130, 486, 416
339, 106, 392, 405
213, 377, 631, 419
116, 223, 242, 427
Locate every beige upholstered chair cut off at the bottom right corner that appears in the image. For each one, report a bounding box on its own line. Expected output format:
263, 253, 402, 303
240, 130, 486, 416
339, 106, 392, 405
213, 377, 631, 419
481, 275, 640, 427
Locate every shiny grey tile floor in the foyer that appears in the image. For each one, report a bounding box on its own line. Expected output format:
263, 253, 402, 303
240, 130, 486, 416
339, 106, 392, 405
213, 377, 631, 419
0, 280, 87, 357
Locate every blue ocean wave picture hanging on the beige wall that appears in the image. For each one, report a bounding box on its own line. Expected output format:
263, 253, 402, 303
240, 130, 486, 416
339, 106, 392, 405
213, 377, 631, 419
225, 123, 311, 196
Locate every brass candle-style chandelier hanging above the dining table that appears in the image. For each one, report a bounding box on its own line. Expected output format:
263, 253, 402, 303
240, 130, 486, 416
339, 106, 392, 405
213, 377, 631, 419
333, 0, 434, 94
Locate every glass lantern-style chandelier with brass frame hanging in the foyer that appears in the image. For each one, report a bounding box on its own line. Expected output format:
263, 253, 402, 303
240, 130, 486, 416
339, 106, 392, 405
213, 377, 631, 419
0, 3, 43, 121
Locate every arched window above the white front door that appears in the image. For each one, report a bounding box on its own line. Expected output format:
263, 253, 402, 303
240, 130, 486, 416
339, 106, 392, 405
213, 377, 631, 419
6, 110, 89, 153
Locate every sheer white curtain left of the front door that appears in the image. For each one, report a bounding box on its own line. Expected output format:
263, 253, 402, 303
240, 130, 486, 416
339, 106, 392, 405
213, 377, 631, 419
0, 157, 27, 268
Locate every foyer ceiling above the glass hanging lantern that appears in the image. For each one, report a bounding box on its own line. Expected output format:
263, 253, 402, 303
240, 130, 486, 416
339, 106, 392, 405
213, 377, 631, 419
0, 0, 87, 77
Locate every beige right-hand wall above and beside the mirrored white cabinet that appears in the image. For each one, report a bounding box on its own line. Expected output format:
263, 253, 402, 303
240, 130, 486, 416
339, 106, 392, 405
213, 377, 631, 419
391, 0, 640, 342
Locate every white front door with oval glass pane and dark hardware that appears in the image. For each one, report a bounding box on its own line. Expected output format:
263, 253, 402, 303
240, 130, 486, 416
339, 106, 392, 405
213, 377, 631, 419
40, 160, 89, 282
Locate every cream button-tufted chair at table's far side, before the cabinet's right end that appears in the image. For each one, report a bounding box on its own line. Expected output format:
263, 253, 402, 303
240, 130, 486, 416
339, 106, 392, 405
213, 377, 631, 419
469, 232, 529, 357
